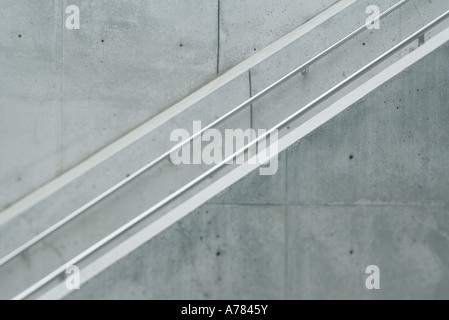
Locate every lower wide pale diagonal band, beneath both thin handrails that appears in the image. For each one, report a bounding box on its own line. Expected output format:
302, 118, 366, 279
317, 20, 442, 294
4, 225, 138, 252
35, 24, 449, 299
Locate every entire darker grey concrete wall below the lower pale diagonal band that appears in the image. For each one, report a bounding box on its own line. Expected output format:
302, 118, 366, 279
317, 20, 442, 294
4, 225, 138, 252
69, 39, 449, 299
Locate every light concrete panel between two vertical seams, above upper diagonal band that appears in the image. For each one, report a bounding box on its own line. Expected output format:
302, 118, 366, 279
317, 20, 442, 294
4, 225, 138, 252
60, 0, 218, 169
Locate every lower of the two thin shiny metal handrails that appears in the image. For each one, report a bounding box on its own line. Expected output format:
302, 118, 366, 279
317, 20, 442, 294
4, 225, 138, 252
14, 10, 449, 300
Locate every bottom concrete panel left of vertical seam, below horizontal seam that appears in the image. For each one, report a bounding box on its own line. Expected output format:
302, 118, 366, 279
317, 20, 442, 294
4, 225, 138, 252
68, 205, 285, 299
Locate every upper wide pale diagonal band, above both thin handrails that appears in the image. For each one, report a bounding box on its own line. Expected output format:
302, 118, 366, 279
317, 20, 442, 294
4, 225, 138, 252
0, 0, 357, 225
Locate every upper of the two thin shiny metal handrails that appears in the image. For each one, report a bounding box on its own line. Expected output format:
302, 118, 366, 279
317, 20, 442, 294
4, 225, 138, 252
0, 0, 409, 267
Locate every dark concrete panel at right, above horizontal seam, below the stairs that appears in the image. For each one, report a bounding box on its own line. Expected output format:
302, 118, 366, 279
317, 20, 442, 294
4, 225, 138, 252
287, 45, 449, 204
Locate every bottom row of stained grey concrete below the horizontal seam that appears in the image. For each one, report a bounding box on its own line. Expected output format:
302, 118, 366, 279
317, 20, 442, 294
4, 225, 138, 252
64, 205, 449, 299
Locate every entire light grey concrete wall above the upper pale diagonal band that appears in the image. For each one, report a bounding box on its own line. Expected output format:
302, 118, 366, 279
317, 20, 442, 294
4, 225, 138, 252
0, 0, 336, 210
